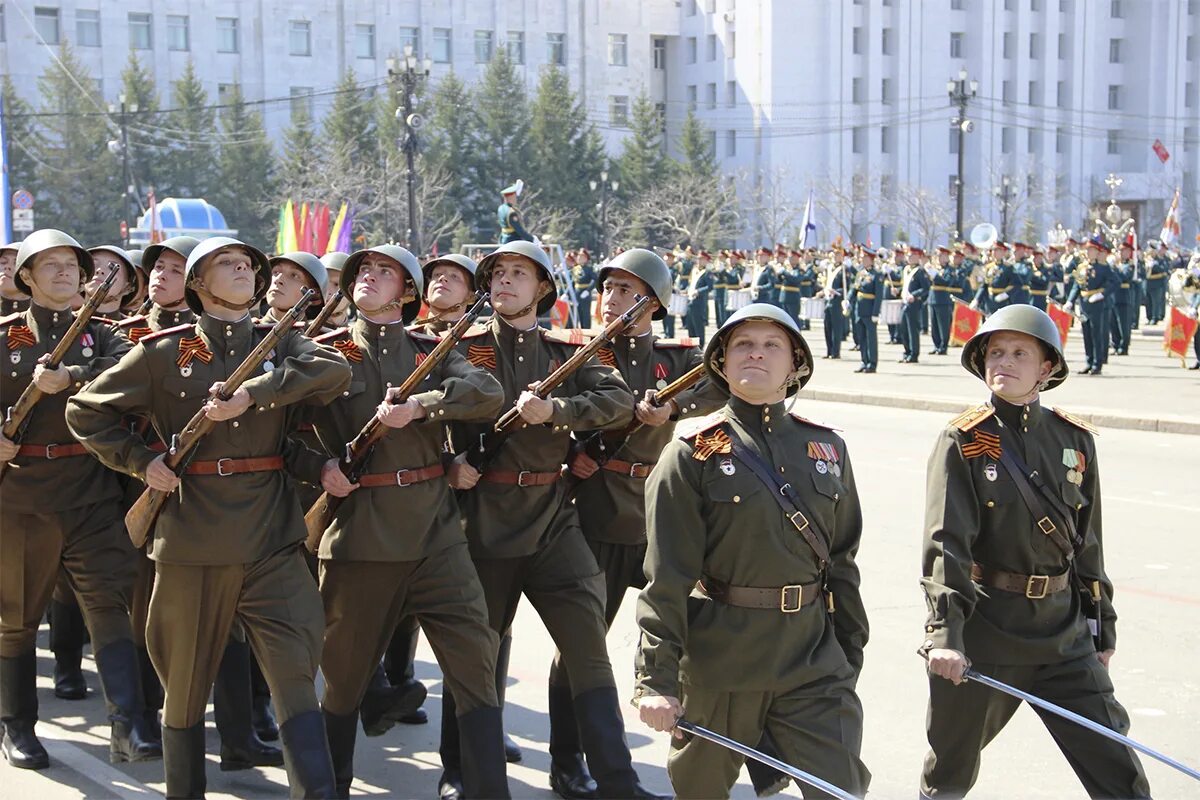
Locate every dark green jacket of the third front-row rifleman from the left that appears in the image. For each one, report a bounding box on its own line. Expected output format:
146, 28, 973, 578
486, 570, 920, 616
305, 317, 504, 561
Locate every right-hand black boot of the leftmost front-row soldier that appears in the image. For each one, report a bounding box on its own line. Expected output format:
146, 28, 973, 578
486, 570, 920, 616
96, 639, 162, 764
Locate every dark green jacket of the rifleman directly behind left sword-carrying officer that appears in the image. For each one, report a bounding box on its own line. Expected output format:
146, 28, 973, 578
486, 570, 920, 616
575, 333, 726, 545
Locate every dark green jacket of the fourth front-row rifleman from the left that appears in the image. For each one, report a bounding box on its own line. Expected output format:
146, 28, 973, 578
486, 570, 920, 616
451, 317, 634, 559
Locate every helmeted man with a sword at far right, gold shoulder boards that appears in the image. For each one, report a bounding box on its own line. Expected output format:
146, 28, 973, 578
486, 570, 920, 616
920, 306, 1150, 798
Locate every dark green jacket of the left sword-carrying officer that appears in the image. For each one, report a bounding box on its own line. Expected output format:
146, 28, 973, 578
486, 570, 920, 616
635, 398, 868, 699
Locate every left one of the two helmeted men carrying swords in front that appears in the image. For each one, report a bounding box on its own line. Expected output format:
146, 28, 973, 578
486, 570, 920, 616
634, 303, 870, 798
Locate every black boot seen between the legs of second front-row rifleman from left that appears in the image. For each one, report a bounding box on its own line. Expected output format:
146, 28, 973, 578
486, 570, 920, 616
212, 639, 283, 772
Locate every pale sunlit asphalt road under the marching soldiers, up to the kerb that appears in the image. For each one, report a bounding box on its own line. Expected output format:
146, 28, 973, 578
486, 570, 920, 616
9, 396, 1200, 800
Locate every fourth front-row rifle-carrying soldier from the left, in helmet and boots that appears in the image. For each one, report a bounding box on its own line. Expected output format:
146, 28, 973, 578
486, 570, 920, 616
439, 242, 667, 798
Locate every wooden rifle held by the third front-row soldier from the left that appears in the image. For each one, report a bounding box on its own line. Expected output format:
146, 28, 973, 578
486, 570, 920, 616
304, 290, 491, 553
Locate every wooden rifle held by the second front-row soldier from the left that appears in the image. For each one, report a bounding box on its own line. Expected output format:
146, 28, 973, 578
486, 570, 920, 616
125, 289, 317, 548
